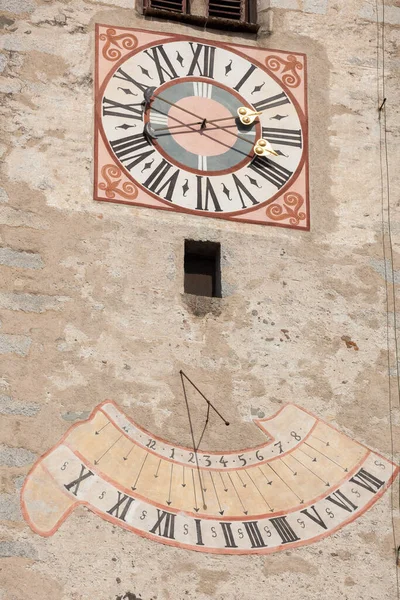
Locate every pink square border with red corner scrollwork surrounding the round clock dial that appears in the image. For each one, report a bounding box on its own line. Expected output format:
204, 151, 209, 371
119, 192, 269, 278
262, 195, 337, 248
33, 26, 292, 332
94, 24, 310, 231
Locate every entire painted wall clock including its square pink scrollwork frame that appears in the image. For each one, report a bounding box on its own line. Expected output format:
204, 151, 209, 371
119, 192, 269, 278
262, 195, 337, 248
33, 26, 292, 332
95, 25, 309, 229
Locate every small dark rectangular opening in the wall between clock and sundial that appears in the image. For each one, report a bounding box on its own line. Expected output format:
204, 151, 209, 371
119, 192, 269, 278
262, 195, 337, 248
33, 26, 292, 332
184, 240, 221, 298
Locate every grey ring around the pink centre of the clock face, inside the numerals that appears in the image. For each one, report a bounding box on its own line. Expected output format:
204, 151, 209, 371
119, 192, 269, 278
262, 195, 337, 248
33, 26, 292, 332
150, 79, 256, 174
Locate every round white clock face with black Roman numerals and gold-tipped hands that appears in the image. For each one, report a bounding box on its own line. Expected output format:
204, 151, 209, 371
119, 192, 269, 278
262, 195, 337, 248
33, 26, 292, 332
98, 37, 306, 218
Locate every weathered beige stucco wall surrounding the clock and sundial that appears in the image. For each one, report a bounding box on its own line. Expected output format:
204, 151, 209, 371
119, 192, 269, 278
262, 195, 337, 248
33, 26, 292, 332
0, 0, 400, 600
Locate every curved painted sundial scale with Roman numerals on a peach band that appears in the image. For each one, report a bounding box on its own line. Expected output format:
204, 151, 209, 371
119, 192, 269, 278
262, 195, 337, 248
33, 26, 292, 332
21, 401, 398, 554
